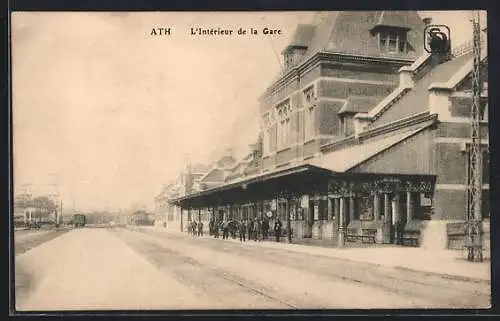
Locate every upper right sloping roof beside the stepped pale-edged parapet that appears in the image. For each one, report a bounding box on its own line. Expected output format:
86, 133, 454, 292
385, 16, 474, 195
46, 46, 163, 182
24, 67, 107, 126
369, 54, 471, 127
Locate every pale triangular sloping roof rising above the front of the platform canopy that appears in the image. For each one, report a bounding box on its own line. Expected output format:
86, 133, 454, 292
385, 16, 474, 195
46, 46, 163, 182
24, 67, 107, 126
311, 122, 432, 173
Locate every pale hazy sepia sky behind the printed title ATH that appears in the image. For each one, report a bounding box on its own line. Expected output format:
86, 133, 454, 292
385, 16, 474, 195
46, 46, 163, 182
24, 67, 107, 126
11, 11, 485, 210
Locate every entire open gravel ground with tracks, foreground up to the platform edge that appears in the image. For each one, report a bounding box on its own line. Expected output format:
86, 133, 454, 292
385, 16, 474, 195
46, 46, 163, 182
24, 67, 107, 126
16, 228, 490, 310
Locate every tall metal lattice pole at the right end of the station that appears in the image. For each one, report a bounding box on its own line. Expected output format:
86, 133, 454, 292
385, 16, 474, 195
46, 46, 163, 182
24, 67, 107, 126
465, 11, 483, 261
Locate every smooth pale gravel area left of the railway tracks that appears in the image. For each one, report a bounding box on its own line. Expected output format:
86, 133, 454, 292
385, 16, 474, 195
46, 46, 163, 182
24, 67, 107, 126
16, 229, 217, 311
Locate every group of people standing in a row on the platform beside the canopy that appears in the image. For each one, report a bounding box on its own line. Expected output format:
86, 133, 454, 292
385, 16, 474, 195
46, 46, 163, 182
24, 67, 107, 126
190, 218, 283, 242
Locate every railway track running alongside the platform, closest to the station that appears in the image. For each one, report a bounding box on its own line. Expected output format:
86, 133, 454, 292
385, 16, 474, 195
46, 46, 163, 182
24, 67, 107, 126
131, 231, 491, 308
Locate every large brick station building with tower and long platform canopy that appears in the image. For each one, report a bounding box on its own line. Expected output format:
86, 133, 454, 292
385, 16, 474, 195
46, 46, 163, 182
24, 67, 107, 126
168, 11, 489, 248
